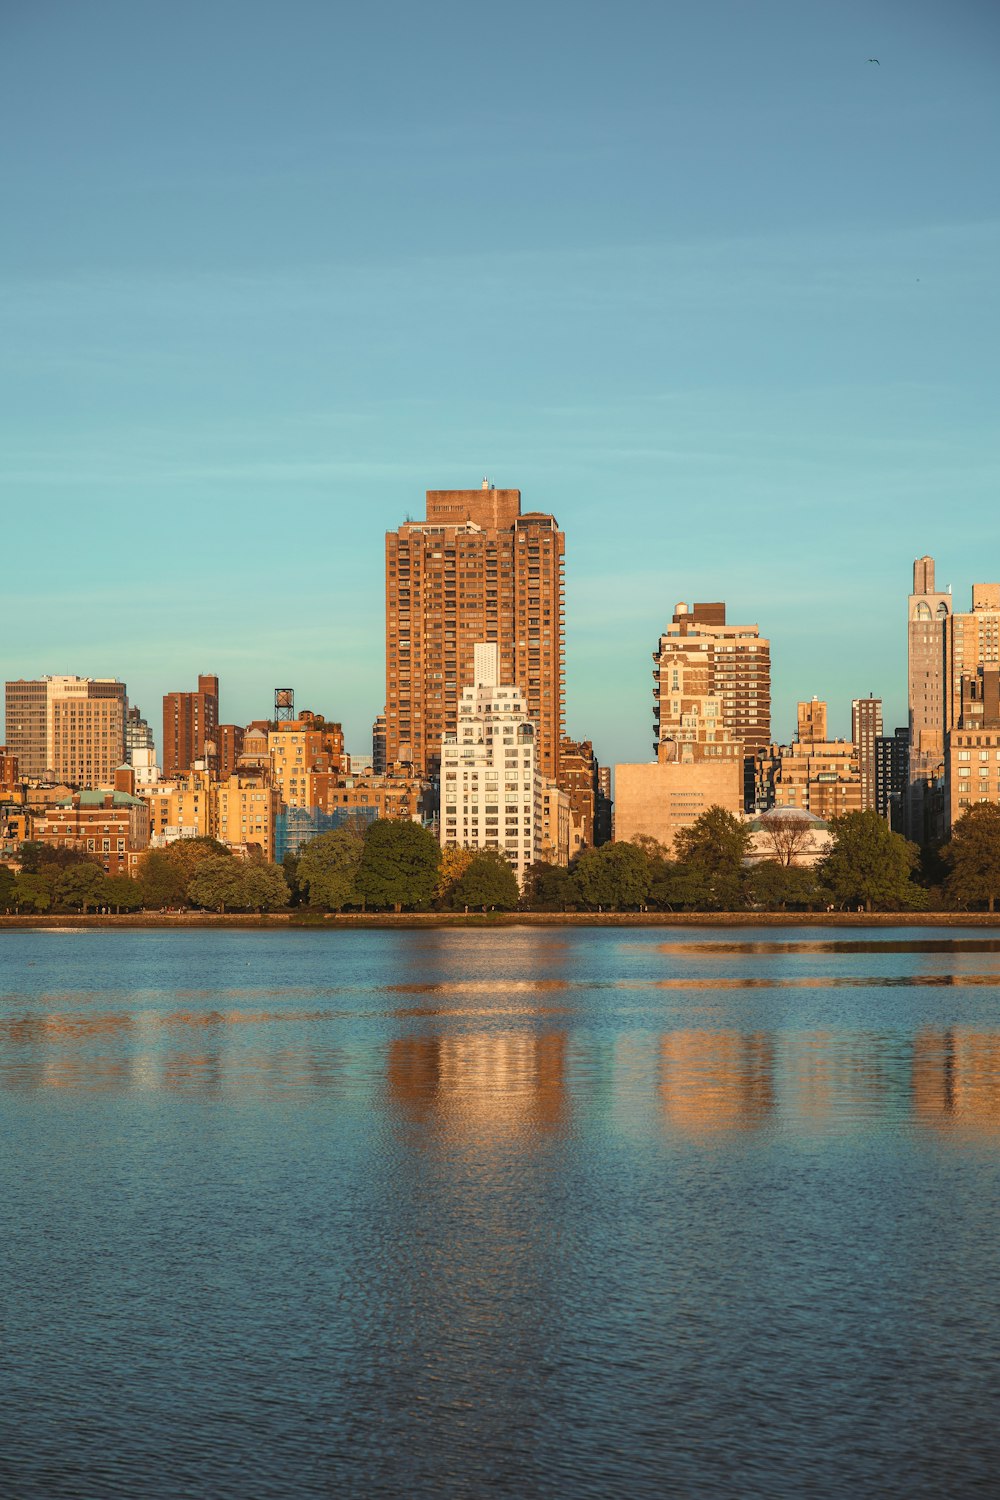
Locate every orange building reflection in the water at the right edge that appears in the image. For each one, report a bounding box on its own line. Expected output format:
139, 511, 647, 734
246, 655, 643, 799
913, 1026, 1000, 1134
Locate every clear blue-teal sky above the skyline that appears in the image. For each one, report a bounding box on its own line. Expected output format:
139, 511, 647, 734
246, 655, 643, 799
0, 0, 1000, 764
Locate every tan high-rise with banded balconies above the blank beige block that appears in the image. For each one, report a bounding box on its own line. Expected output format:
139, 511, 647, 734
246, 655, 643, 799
652, 603, 771, 809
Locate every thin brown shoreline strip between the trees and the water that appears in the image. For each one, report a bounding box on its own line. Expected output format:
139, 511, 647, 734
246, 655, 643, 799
0, 912, 1000, 932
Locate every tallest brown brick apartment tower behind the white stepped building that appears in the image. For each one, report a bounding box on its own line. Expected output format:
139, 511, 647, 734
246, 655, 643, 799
385, 480, 565, 779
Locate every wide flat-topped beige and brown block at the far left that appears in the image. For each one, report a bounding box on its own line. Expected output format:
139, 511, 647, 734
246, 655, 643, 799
6, 677, 127, 788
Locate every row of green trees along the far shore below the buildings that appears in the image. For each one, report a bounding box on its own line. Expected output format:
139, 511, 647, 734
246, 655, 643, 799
0, 803, 1000, 912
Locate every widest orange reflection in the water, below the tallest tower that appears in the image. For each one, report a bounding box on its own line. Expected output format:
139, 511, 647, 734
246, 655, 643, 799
387, 1031, 567, 1137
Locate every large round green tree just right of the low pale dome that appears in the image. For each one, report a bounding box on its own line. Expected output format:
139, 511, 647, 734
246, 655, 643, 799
819, 810, 927, 912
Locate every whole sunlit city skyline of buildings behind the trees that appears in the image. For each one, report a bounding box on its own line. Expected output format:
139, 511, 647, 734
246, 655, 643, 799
0, 480, 1000, 884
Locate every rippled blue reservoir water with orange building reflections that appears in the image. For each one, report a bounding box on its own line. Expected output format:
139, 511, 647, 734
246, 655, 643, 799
0, 921, 1000, 1500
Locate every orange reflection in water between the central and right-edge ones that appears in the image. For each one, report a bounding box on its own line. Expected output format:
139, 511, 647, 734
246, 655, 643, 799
660, 1031, 775, 1136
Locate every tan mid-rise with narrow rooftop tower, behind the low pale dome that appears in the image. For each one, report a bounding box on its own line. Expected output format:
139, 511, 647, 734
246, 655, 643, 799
756, 698, 862, 822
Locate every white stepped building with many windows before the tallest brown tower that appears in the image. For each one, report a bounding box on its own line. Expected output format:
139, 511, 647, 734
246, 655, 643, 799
441, 641, 542, 885
